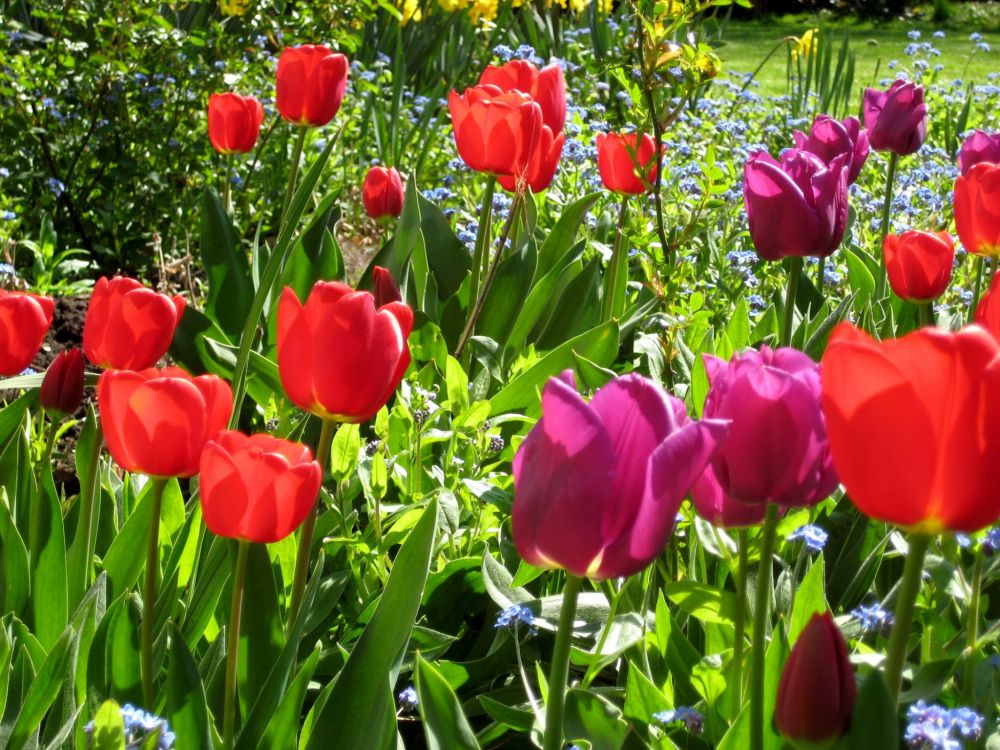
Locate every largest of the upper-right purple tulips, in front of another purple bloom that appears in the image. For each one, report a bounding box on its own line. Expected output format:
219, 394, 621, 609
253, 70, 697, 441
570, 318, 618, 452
743, 148, 848, 260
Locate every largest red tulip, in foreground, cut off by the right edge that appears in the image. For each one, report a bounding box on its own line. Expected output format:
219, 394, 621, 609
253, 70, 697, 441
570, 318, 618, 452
820, 323, 1000, 534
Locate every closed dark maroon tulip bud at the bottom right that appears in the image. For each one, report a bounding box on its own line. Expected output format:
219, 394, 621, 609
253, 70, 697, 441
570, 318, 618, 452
774, 612, 857, 750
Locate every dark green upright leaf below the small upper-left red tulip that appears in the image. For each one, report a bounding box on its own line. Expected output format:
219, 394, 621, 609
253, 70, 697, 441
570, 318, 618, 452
201, 188, 253, 341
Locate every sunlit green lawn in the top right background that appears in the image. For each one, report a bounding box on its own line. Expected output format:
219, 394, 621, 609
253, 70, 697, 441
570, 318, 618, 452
717, 15, 1000, 95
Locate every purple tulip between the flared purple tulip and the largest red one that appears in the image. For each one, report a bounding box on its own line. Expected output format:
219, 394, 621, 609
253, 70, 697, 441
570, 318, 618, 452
702, 346, 839, 507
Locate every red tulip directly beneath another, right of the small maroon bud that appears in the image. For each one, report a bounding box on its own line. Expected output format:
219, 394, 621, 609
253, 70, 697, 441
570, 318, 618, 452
97, 367, 233, 478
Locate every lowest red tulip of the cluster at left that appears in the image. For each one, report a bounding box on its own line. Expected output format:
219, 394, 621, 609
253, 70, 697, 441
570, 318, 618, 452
199, 431, 322, 544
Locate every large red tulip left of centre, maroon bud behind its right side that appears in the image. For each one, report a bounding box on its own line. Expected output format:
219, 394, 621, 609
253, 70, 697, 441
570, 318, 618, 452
278, 281, 413, 422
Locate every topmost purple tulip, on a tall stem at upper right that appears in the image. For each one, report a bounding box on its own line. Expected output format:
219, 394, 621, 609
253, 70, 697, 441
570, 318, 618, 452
864, 81, 927, 156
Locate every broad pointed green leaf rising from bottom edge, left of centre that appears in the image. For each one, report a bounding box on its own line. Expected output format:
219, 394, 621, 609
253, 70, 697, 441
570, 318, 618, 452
306, 500, 438, 750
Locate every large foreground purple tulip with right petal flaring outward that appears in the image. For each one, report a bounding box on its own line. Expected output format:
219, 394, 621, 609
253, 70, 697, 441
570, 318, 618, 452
512, 371, 726, 579
